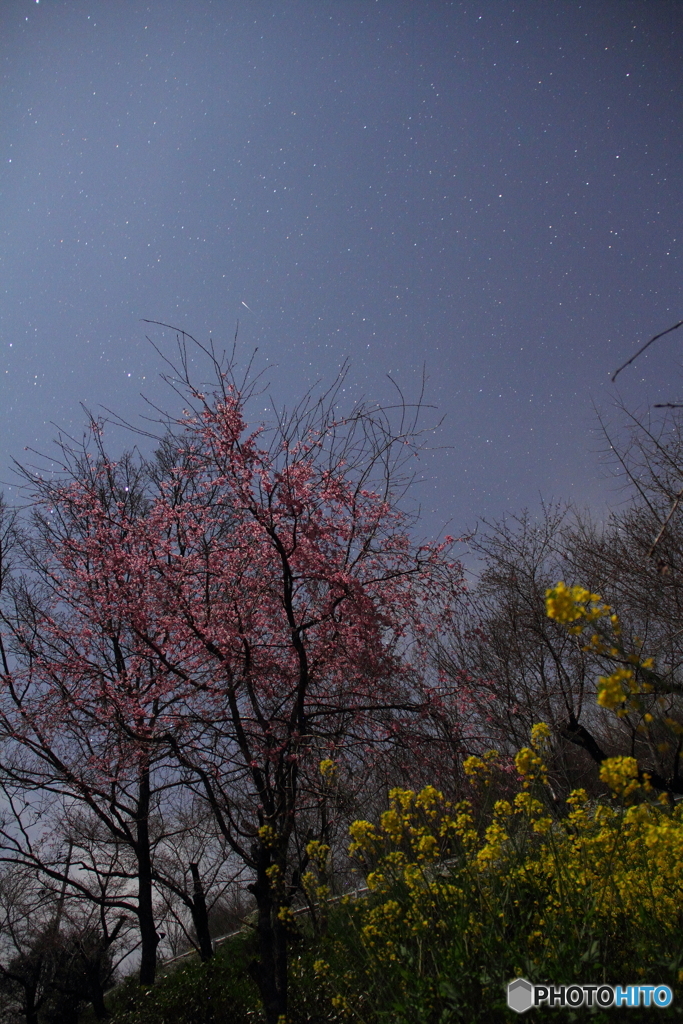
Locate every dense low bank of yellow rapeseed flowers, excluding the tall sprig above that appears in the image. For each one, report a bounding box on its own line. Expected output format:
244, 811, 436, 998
327, 733, 683, 1021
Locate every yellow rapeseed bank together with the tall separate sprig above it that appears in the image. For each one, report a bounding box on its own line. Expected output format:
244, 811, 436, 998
311, 583, 683, 1024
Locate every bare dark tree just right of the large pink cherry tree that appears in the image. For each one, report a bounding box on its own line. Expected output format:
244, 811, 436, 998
432, 506, 607, 791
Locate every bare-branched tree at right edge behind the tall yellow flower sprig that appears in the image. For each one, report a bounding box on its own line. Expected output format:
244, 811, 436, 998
544, 403, 683, 794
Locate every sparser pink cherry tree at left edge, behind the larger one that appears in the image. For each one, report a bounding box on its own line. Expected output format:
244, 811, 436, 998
0, 468, 210, 984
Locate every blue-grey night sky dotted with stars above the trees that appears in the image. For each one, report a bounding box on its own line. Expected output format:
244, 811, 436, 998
0, 0, 683, 535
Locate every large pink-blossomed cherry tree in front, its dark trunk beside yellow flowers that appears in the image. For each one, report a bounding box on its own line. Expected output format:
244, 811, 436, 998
3, 338, 461, 1024
